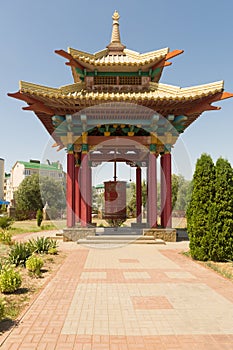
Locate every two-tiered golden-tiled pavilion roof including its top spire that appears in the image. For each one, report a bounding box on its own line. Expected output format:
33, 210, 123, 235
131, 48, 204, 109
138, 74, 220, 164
9, 11, 233, 146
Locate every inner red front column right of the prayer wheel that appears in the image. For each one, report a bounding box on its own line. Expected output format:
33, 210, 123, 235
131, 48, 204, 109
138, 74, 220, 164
147, 144, 157, 227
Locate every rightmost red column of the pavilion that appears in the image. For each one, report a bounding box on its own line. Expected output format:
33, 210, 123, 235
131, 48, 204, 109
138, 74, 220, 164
160, 151, 172, 227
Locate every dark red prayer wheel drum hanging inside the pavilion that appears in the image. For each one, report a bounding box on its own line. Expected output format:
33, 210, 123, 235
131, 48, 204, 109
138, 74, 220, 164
104, 181, 126, 220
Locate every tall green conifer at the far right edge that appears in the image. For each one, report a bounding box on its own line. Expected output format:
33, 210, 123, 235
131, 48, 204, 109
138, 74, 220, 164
209, 158, 233, 261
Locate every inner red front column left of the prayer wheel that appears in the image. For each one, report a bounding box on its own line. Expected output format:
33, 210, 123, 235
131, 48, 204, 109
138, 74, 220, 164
80, 135, 88, 227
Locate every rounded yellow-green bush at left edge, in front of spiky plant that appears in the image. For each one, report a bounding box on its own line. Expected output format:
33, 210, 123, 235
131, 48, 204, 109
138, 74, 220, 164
0, 266, 22, 293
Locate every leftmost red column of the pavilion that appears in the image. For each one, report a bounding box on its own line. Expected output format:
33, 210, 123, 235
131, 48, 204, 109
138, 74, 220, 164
66, 145, 75, 227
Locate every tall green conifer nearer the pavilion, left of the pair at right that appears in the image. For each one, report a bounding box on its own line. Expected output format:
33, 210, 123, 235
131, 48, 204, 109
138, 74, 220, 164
187, 154, 215, 260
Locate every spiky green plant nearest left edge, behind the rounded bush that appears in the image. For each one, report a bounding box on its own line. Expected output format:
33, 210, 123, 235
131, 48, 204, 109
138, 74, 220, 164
8, 242, 32, 266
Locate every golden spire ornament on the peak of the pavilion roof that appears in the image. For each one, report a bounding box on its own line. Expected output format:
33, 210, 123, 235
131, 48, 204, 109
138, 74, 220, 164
107, 10, 125, 55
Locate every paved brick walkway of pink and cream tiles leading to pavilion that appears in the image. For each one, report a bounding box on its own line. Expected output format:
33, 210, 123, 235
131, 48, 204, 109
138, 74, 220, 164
0, 235, 233, 350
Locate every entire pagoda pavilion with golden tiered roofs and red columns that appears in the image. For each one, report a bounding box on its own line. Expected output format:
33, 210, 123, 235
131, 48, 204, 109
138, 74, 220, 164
9, 11, 233, 241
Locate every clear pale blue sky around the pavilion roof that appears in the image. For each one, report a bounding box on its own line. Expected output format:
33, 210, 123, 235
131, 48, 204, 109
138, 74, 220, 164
0, 0, 233, 182
